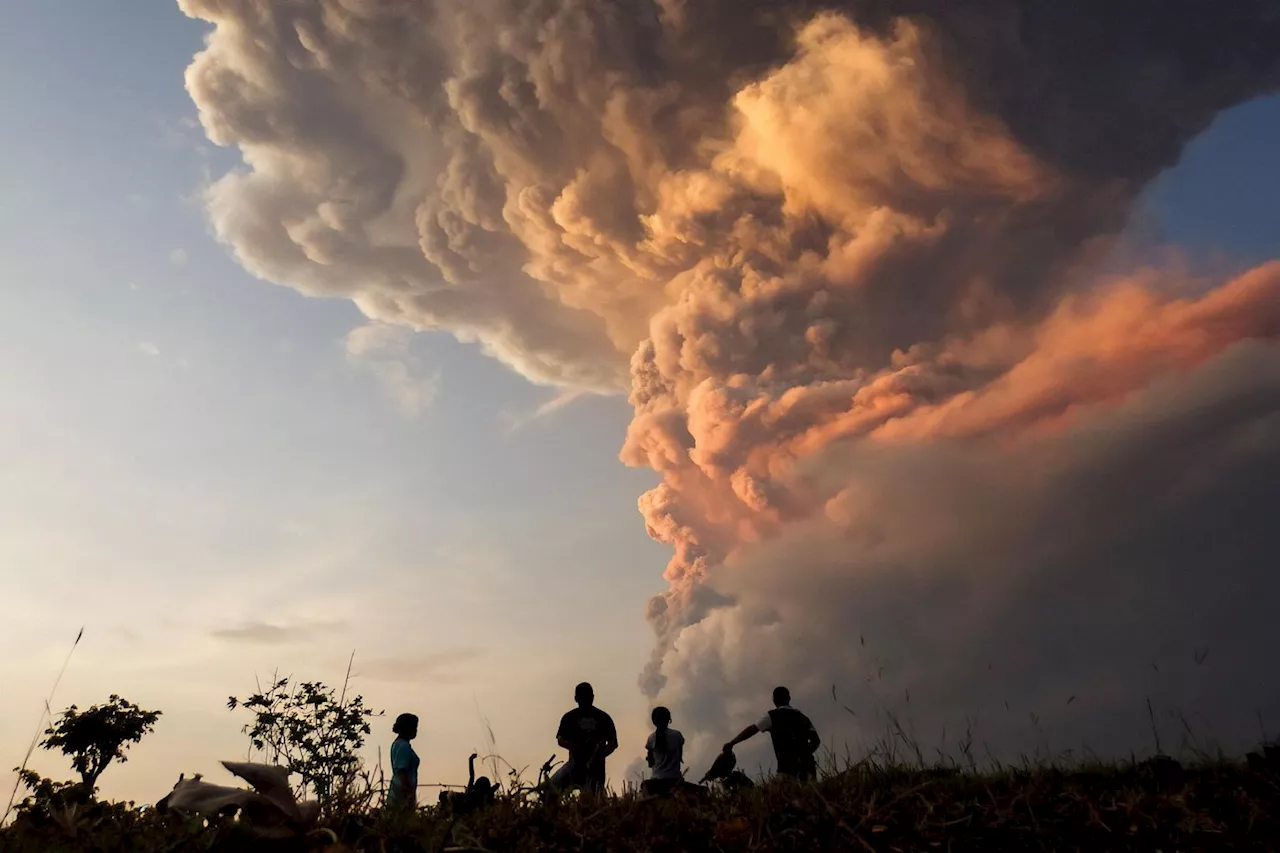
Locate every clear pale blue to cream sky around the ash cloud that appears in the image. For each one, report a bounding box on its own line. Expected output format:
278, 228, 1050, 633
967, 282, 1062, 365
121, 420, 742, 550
0, 0, 1280, 800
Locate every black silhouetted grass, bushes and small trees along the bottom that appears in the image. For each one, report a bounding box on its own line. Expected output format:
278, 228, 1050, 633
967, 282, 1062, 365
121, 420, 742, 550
0, 660, 1280, 853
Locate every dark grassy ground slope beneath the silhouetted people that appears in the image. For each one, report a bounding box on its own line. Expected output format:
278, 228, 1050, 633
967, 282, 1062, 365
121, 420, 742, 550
0, 753, 1280, 853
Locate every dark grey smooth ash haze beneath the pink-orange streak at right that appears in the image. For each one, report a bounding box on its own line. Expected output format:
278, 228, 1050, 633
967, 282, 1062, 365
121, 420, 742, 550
672, 343, 1280, 761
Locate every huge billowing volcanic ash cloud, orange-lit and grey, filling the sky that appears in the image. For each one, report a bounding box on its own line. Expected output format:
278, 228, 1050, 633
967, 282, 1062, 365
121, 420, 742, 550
180, 0, 1280, 748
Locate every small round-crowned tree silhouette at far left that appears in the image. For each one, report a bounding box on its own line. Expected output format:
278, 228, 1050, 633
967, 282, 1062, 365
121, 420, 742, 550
40, 693, 160, 793
